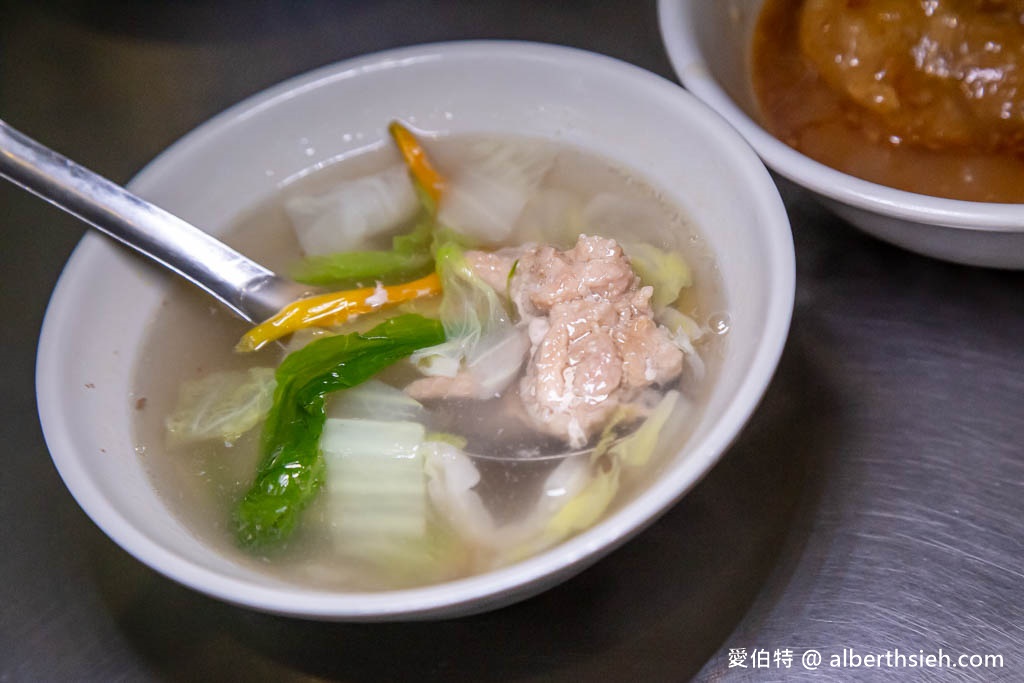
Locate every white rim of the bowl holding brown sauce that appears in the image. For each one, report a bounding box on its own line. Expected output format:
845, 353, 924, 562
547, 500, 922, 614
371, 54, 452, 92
657, 0, 1024, 234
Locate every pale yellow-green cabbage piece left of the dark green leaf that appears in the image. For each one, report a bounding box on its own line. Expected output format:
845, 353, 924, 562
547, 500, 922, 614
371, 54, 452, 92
166, 368, 274, 443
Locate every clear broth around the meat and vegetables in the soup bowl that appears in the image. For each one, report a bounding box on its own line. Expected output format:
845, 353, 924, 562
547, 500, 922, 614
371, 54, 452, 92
131, 132, 728, 591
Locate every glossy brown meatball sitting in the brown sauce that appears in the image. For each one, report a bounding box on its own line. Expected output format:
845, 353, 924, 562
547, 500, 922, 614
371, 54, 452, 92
800, 0, 1024, 151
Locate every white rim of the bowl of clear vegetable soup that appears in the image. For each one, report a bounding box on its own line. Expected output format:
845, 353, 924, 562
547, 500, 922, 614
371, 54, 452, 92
36, 40, 796, 621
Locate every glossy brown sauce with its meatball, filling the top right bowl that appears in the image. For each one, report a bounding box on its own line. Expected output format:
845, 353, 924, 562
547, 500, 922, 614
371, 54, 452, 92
752, 0, 1024, 203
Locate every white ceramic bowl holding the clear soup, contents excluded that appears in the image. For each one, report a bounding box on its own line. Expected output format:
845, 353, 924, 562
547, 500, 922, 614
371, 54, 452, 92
37, 42, 795, 621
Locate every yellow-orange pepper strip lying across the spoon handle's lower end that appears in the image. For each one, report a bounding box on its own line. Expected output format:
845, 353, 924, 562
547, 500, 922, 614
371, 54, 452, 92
234, 272, 441, 351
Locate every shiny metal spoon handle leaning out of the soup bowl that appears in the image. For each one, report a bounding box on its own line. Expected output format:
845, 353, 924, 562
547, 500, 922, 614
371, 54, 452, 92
0, 120, 305, 323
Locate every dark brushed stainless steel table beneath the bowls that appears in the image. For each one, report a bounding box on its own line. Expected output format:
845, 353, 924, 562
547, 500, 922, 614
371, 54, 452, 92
0, 0, 1024, 681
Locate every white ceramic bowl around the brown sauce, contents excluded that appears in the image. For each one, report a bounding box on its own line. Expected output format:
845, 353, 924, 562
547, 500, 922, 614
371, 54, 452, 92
658, 0, 1024, 268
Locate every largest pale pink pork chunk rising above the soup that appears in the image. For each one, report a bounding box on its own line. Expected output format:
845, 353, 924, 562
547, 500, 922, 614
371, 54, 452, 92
510, 236, 683, 447
